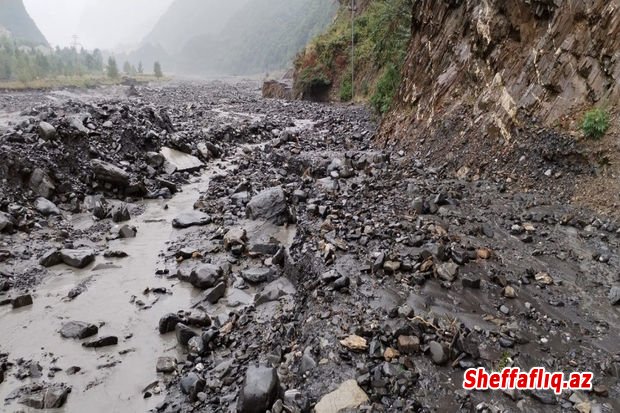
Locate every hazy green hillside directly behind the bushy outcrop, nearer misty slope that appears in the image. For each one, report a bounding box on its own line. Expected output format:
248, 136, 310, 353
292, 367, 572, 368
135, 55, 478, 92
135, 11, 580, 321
181, 0, 337, 74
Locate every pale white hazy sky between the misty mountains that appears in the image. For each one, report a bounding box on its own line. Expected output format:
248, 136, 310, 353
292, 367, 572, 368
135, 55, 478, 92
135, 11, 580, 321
24, 0, 174, 49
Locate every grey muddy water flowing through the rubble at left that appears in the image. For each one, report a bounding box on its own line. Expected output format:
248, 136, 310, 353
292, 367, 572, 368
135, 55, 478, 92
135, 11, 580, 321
0, 159, 247, 413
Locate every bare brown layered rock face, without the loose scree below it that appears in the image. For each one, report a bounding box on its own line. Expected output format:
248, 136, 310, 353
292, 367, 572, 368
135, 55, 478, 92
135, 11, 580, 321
383, 0, 620, 144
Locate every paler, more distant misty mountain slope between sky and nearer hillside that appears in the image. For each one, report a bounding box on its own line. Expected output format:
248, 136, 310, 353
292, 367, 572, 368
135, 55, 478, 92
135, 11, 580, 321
142, 0, 250, 54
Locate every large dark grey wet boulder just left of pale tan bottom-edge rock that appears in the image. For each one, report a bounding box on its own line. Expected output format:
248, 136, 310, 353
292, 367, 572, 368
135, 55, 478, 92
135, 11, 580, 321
237, 366, 279, 413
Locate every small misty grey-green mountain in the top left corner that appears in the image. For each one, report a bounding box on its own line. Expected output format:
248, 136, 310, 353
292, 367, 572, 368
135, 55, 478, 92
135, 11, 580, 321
0, 0, 47, 45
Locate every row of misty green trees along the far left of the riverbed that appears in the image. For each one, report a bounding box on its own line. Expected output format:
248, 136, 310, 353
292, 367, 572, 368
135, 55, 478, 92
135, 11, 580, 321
0, 37, 103, 83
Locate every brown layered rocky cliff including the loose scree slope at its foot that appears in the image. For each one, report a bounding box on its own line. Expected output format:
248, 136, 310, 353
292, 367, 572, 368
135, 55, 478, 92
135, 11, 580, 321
382, 0, 620, 212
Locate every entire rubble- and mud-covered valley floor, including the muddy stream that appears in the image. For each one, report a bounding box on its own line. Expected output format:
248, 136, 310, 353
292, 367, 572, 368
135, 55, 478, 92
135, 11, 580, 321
0, 82, 620, 413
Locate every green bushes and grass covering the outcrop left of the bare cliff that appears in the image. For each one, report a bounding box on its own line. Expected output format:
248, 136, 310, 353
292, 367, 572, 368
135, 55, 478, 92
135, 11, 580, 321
295, 0, 414, 113
